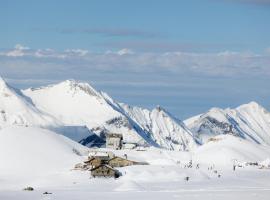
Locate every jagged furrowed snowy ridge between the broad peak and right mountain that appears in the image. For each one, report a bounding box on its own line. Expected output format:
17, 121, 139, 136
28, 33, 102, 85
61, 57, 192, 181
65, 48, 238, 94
122, 104, 197, 151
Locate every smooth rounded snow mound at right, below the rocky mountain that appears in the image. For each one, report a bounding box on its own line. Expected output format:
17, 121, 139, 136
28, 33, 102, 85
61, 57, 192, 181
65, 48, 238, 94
192, 134, 270, 167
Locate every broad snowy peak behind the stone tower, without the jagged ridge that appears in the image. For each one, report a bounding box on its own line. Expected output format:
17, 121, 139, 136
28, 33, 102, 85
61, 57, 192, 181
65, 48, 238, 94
23, 80, 155, 148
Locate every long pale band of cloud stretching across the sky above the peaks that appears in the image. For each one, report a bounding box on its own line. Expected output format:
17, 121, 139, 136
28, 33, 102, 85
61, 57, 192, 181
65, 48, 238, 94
0, 45, 270, 77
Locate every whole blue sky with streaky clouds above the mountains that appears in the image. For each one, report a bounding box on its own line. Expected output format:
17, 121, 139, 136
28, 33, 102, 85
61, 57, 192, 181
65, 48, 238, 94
0, 0, 270, 119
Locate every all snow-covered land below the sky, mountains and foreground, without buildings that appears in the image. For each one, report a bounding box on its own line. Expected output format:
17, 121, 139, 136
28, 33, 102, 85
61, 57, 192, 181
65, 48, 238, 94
0, 78, 270, 200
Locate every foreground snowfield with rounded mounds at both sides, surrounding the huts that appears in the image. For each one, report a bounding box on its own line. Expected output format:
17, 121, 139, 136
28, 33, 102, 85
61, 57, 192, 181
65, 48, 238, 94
0, 126, 270, 200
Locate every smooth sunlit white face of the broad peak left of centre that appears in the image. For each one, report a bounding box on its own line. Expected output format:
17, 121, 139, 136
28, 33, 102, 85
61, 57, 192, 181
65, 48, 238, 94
23, 80, 120, 127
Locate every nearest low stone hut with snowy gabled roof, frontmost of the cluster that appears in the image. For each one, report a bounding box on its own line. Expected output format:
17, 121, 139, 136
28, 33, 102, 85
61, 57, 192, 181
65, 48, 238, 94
91, 164, 121, 178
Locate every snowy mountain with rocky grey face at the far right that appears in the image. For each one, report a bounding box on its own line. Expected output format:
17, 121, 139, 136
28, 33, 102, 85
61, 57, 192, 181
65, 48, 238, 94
184, 102, 270, 145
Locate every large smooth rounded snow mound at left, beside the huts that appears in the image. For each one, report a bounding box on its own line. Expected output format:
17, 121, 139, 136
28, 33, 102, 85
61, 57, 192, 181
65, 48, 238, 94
0, 126, 87, 188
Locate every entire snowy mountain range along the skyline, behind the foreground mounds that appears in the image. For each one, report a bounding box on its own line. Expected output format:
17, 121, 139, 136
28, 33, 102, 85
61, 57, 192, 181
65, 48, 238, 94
0, 78, 270, 151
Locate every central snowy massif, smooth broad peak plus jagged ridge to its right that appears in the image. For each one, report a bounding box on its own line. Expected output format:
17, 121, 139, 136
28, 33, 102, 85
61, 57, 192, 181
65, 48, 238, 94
23, 80, 197, 150
